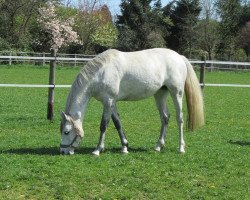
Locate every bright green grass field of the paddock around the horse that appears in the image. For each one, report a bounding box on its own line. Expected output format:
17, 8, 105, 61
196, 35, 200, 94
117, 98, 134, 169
0, 66, 250, 200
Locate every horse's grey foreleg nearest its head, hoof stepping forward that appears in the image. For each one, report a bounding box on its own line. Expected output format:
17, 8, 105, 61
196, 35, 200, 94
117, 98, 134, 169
92, 105, 111, 156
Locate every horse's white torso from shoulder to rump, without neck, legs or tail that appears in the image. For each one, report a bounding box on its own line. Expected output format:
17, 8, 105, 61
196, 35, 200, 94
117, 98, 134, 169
91, 49, 187, 100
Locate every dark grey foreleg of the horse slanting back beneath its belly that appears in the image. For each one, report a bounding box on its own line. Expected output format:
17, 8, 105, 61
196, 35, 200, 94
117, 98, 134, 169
111, 105, 128, 153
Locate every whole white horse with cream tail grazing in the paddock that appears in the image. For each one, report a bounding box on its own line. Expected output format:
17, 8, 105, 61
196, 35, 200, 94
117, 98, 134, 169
60, 48, 204, 155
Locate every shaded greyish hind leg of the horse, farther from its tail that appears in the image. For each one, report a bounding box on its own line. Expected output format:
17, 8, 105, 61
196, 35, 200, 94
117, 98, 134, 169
154, 89, 170, 151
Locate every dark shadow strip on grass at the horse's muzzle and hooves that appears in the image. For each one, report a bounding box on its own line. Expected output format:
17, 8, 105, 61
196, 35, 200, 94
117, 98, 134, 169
0, 147, 148, 156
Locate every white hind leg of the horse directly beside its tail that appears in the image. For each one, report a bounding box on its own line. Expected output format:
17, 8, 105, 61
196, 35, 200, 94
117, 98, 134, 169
171, 89, 185, 153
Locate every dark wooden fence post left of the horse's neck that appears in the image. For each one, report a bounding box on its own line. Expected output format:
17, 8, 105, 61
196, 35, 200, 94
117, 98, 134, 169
47, 49, 56, 121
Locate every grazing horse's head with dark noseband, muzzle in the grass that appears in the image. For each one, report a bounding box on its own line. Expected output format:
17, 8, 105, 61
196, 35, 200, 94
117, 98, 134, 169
60, 112, 84, 154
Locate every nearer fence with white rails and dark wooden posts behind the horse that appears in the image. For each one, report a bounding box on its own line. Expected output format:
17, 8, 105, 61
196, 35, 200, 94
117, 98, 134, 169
0, 52, 250, 120
